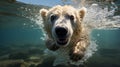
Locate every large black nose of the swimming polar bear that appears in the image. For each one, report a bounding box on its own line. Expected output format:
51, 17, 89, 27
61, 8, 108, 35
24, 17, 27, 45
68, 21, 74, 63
55, 27, 68, 38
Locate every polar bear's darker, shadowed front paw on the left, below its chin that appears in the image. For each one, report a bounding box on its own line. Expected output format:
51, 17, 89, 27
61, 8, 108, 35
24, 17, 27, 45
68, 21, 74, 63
45, 39, 60, 51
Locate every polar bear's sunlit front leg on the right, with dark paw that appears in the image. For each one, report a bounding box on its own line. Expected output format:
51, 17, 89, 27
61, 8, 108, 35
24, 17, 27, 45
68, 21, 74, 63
69, 41, 87, 61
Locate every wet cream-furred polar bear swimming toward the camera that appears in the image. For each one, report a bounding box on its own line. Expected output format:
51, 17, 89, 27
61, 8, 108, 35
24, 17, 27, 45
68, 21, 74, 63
40, 5, 89, 61
